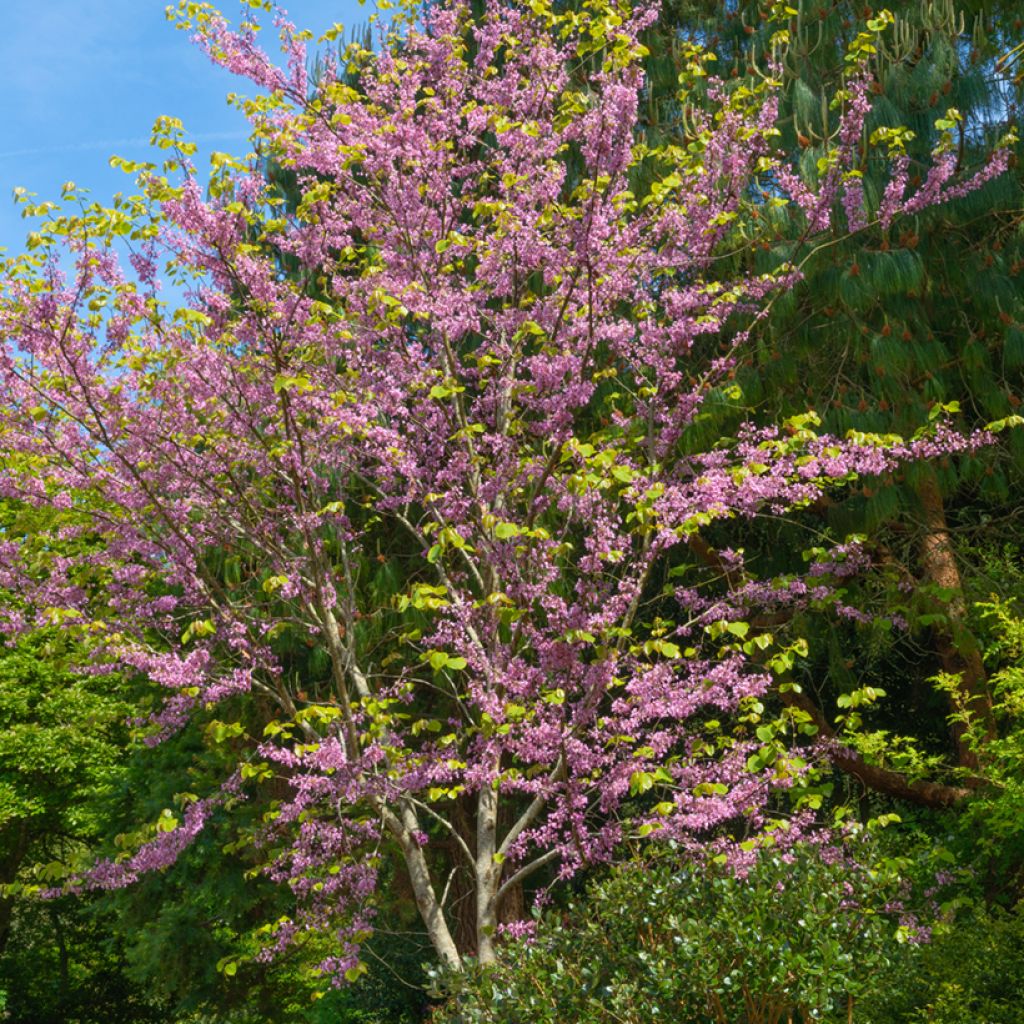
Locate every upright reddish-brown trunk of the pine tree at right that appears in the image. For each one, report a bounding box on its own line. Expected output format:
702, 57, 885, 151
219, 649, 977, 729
918, 469, 996, 770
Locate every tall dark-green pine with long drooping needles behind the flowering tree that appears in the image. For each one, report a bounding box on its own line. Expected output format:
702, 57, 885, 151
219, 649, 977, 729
648, 0, 1024, 768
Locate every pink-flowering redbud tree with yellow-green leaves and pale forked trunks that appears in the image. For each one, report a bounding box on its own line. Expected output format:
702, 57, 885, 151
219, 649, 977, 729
0, 0, 998, 978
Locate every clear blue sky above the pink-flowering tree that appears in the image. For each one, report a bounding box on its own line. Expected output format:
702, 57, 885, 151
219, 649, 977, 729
0, 0, 372, 252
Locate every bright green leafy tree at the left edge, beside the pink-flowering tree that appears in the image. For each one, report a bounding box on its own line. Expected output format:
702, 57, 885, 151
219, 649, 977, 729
0, 493, 169, 1024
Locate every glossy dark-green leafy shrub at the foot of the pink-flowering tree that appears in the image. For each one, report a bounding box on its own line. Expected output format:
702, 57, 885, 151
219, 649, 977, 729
436, 847, 916, 1024
